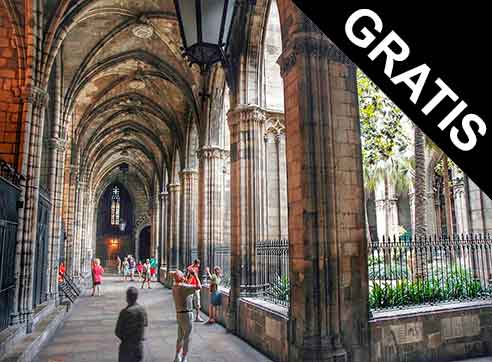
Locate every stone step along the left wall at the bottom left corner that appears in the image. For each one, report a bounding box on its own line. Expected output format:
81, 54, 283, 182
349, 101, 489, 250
0, 305, 68, 362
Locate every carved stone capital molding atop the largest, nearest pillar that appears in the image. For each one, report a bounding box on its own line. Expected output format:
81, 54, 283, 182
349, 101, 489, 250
277, 32, 352, 76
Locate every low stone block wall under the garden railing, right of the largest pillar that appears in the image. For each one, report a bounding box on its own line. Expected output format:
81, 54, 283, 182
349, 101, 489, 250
369, 302, 492, 362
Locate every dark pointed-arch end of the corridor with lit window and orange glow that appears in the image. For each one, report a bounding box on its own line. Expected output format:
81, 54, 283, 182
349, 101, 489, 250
95, 182, 135, 267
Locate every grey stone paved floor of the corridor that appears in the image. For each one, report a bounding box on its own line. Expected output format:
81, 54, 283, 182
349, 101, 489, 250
37, 277, 270, 362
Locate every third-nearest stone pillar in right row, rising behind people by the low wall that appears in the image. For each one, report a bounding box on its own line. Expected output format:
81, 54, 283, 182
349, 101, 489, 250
198, 145, 227, 280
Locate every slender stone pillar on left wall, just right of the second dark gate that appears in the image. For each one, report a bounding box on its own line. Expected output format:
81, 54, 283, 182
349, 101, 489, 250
48, 137, 66, 300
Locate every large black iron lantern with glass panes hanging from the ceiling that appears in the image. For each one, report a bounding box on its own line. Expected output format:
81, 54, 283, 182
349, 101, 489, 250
174, 0, 237, 73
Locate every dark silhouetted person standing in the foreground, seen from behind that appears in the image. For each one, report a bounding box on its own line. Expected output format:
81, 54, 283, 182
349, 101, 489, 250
115, 287, 148, 362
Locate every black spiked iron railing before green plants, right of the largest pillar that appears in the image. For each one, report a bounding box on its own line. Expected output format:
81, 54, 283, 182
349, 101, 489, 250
368, 234, 492, 310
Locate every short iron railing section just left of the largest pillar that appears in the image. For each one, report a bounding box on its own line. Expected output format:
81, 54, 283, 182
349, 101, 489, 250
256, 240, 290, 306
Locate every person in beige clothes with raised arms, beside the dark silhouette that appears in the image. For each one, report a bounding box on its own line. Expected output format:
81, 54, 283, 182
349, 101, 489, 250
172, 270, 202, 362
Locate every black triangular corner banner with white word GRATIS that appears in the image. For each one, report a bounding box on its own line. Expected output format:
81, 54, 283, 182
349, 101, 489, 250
293, 0, 492, 197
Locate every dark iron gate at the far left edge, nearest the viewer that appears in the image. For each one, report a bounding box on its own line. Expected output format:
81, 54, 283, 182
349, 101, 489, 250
0, 174, 20, 331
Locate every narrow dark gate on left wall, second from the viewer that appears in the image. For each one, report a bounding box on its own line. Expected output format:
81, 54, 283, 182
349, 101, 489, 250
33, 191, 50, 307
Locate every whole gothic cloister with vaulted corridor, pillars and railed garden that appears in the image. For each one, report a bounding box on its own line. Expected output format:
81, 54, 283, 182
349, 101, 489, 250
0, 0, 492, 362
